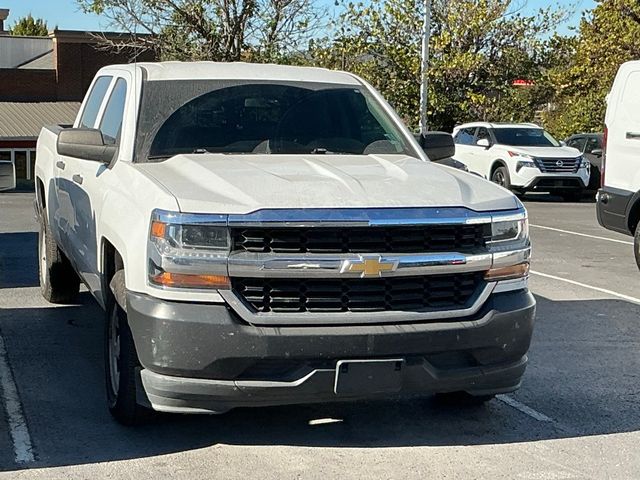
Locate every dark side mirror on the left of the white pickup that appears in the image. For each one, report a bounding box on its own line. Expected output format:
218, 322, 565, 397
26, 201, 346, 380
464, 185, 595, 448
56, 128, 117, 163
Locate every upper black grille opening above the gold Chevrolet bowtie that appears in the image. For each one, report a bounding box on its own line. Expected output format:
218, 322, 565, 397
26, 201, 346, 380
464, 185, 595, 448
232, 224, 491, 253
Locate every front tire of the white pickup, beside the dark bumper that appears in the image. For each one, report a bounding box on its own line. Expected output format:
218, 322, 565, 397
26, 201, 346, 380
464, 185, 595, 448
104, 270, 151, 426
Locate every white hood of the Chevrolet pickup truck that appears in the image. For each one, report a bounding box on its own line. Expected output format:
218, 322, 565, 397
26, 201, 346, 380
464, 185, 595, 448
137, 154, 518, 214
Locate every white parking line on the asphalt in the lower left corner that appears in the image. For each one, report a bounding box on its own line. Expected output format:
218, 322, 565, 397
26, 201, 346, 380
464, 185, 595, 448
0, 336, 35, 463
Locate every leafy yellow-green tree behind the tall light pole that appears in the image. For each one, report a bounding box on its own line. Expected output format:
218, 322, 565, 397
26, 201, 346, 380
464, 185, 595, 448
313, 0, 565, 130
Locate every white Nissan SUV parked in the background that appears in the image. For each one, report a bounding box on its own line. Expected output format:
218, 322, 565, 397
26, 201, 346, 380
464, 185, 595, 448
453, 122, 590, 200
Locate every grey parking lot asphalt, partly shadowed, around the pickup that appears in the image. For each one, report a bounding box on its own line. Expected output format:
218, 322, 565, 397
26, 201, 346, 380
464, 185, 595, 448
0, 193, 640, 479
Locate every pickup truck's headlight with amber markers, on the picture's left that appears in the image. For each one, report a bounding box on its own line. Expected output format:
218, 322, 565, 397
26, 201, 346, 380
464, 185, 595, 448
148, 210, 231, 289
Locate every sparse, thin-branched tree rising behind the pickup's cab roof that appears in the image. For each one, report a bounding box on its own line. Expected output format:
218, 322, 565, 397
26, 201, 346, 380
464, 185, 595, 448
77, 0, 325, 62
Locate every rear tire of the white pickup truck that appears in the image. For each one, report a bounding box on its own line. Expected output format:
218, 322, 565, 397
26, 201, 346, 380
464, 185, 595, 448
38, 216, 80, 303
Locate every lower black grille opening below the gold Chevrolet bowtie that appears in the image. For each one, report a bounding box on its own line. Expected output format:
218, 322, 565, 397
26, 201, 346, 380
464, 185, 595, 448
231, 272, 484, 313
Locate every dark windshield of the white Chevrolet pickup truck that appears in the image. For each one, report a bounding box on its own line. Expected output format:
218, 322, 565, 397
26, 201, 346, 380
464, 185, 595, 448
142, 81, 417, 161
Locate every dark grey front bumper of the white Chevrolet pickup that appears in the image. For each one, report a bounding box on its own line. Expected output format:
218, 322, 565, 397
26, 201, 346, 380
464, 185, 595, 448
127, 290, 535, 413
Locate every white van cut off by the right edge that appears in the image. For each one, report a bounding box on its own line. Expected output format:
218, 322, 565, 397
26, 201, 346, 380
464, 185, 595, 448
597, 61, 640, 267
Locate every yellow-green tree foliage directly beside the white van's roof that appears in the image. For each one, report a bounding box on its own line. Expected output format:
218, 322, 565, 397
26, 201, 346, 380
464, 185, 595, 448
543, 0, 640, 137
